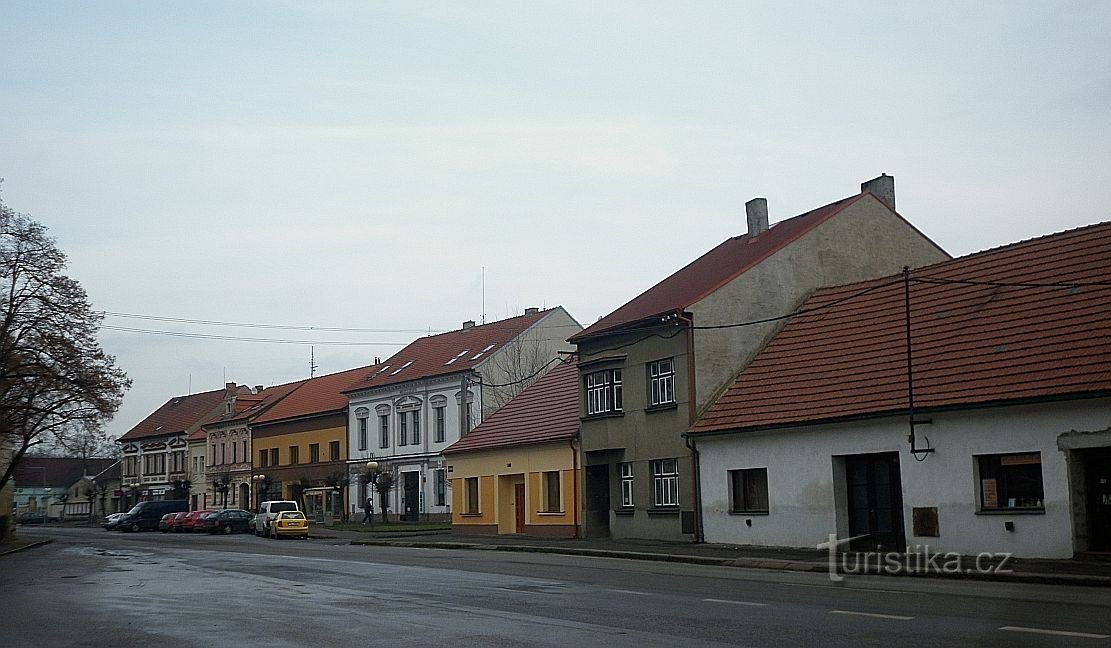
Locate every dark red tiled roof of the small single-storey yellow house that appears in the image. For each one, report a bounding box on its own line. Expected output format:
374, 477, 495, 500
444, 362, 579, 453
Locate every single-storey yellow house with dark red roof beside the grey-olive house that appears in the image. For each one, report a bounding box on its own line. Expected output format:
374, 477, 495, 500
444, 361, 582, 538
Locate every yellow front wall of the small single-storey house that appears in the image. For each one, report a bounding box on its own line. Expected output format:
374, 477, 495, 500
448, 440, 580, 537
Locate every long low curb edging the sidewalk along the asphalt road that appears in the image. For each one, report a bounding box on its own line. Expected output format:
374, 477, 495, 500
349, 540, 1111, 587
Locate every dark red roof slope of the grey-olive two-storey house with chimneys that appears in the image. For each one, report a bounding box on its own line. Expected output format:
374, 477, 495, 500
569, 193, 864, 342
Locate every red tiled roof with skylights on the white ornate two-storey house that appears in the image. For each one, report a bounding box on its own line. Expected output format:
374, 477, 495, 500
346, 307, 558, 391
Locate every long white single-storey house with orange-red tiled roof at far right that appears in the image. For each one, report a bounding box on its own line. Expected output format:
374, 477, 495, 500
689, 223, 1111, 558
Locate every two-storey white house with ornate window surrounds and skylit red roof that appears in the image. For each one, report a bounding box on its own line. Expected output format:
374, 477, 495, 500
346, 307, 581, 521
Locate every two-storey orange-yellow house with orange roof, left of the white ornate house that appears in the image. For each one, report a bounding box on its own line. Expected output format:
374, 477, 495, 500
251, 366, 377, 520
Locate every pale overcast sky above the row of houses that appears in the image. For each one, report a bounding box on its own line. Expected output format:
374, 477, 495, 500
0, 0, 1111, 435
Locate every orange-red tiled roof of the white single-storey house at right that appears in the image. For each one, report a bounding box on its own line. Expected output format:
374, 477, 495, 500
693, 222, 1111, 432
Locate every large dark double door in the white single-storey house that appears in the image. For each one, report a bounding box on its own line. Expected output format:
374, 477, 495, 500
845, 452, 907, 551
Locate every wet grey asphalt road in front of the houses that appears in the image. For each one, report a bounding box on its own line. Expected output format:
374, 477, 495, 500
0, 528, 1111, 648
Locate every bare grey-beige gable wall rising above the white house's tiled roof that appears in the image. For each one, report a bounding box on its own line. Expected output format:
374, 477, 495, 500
690, 195, 949, 412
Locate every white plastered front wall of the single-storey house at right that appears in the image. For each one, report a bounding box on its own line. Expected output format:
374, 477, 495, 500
698, 399, 1111, 558
